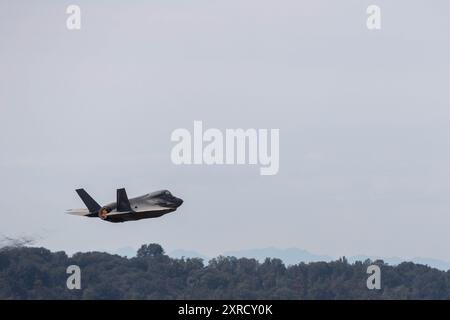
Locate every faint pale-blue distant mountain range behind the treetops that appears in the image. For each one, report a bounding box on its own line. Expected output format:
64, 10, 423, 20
110, 247, 450, 271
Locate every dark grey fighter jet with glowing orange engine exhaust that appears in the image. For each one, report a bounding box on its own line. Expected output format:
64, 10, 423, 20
66, 188, 183, 222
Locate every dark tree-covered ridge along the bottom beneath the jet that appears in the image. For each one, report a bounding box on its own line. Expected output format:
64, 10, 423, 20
0, 244, 450, 299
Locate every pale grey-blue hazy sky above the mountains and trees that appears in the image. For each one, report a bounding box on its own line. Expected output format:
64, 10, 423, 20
0, 0, 450, 261
